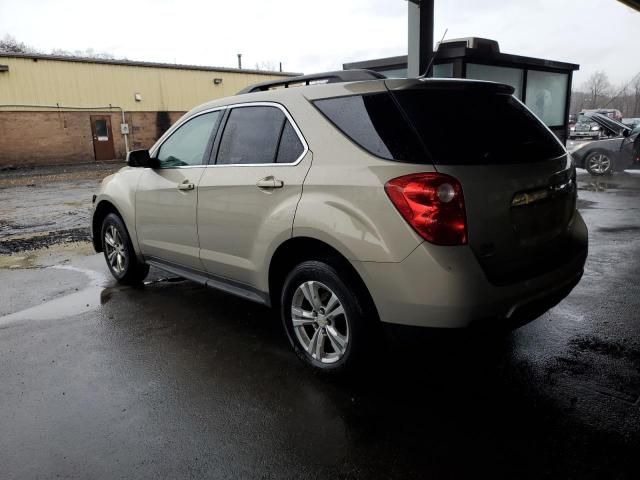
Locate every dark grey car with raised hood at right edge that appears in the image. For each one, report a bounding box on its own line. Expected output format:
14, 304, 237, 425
571, 113, 640, 176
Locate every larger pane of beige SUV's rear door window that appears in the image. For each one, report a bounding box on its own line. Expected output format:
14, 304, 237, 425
217, 107, 286, 165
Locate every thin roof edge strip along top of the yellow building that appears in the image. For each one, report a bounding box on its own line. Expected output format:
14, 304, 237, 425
0, 52, 302, 77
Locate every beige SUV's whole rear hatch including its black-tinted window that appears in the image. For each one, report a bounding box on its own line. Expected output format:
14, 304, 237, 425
387, 80, 582, 285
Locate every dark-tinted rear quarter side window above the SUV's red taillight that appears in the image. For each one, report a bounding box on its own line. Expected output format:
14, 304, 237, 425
314, 93, 430, 163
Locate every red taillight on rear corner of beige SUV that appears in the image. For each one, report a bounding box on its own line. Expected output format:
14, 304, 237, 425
384, 173, 467, 245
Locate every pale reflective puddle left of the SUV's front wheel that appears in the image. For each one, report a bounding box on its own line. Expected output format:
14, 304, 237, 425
0, 265, 109, 327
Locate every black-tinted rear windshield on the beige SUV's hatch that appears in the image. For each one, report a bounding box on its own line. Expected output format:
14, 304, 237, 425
393, 88, 564, 165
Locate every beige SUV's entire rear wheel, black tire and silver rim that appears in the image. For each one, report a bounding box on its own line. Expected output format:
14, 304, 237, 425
281, 261, 375, 373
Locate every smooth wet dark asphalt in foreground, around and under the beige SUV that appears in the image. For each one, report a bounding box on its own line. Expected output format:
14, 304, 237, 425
0, 173, 640, 479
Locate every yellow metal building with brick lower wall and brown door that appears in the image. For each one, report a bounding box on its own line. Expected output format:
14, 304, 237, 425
0, 53, 296, 166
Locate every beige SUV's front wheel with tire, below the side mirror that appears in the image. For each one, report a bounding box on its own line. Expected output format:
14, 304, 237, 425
100, 213, 149, 285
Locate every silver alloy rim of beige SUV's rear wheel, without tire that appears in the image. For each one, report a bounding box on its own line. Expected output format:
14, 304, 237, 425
291, 280, 350, 363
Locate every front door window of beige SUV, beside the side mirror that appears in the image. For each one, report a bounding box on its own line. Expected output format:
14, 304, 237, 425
157, 111, 221, 168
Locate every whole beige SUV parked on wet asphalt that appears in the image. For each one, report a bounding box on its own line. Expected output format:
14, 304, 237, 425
92, 71, 587, 372
